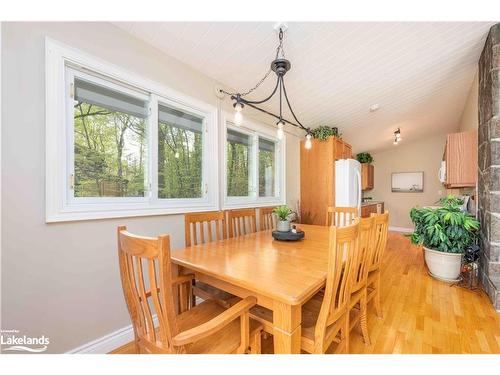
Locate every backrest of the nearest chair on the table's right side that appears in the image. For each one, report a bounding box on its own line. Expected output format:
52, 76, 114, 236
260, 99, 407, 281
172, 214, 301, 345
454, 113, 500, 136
314, 219, 360, 347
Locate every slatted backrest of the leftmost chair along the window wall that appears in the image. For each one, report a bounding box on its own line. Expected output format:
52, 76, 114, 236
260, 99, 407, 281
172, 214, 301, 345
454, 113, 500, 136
184, 211, 227, 246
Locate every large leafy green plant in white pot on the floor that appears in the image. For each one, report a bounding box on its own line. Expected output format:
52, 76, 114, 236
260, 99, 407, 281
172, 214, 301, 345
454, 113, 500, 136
410, 196, 480, 282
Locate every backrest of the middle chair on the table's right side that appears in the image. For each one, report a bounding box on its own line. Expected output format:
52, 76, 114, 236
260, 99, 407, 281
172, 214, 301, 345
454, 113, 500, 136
351, 217, 375, 292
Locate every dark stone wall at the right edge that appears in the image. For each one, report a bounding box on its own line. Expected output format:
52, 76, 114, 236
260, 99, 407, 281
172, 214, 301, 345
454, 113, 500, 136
478, 23, 500, 311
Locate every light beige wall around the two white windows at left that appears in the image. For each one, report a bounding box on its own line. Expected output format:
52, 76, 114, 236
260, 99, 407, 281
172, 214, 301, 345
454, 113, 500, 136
1, 23, 300, 353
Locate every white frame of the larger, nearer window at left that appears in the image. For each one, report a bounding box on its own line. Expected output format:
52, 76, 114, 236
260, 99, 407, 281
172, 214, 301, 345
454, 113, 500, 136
45, 38, 219, 222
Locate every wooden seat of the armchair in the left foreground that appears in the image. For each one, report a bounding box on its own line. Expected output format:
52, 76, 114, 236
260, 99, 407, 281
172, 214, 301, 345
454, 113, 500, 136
177, 300, 262, 354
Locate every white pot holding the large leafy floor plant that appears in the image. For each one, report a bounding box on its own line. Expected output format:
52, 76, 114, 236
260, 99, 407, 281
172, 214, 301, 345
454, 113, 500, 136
424, 246, 462, 282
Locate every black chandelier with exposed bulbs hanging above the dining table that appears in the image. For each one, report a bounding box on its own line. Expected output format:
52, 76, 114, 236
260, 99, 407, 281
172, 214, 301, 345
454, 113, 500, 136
220, 24, 312, 149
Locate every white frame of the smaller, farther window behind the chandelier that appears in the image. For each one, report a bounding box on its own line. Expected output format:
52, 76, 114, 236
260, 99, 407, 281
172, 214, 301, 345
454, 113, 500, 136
219, 112, 286, 209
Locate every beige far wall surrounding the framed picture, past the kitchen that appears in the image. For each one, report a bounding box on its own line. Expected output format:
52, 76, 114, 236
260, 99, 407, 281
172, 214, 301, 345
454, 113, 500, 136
365, 134, 446, 228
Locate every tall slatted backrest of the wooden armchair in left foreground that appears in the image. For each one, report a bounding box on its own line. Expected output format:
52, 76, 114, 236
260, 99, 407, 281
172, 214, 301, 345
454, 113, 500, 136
118, 226, 185, 353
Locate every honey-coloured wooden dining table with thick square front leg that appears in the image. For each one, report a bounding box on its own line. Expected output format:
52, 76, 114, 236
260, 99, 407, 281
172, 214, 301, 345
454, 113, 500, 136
171, 224, 329, 354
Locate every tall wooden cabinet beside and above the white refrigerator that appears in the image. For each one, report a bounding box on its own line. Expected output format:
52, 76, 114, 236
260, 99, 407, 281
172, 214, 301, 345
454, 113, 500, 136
300, 137, 352, 225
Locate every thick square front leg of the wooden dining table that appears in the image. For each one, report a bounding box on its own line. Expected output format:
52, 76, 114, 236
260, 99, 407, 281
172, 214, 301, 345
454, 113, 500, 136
273, 301, 302, 354
